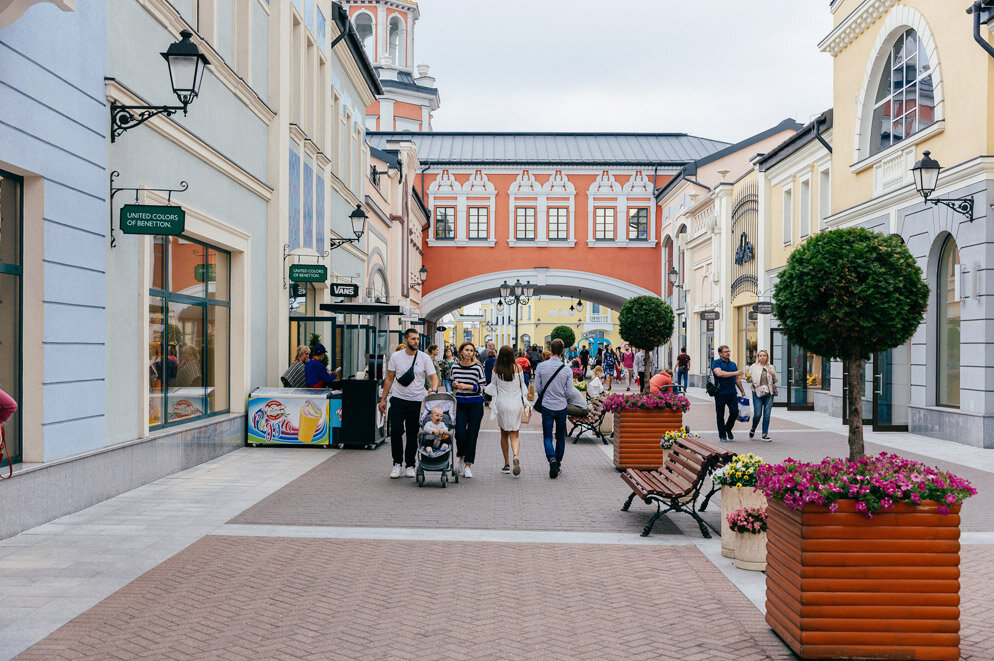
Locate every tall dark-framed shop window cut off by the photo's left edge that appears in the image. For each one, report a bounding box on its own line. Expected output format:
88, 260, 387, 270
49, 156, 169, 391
0, 170, 23, 463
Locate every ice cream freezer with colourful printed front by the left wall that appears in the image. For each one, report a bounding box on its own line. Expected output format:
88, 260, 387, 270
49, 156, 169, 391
246, 388, 342, 447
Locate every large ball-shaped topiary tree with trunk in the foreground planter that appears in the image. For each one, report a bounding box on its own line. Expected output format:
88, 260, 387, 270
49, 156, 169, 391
773, 227, 929, 459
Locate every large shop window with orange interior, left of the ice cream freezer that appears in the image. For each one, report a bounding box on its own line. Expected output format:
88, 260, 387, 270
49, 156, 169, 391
148, 236, 231, 427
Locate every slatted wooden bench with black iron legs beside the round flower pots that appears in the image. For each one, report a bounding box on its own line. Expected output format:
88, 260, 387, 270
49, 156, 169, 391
621, 438, 735, 538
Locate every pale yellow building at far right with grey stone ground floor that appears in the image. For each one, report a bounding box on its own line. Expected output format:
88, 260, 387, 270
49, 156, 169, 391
815, 0, 994, 447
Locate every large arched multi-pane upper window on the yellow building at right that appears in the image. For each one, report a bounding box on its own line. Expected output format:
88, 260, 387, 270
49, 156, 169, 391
867, 29, 935, 156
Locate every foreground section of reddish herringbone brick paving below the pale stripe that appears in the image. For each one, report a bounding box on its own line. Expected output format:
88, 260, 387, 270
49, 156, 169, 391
18, 536, 793, 661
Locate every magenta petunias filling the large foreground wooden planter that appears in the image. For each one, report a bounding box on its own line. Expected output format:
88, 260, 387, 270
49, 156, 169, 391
755, 452, 977, 519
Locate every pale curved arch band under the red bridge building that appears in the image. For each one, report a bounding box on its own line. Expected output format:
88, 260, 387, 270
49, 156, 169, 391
421, 265, 659, 322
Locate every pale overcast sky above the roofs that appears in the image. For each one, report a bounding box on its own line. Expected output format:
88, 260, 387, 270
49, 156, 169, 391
414, 0, 832, 142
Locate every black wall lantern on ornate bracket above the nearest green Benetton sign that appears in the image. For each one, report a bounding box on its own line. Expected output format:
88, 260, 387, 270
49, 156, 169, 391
110, 30, 210, 142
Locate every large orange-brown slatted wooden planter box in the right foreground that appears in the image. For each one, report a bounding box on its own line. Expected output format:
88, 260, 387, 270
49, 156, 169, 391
766, 500, 960, 661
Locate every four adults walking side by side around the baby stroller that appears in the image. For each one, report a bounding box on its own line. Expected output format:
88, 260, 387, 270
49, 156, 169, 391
379, 330, 586, 479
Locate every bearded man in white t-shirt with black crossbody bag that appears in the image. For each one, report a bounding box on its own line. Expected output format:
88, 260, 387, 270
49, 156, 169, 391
380, 328, 438, 478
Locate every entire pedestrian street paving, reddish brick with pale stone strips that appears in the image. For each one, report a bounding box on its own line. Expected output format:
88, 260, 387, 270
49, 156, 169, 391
0, 391, 994, 659
